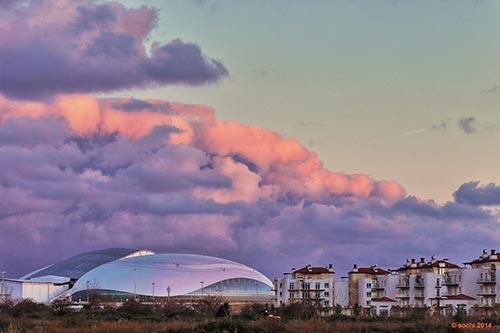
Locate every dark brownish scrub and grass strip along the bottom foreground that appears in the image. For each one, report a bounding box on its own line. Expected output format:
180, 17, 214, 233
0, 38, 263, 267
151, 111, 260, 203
0, 301, 500, 333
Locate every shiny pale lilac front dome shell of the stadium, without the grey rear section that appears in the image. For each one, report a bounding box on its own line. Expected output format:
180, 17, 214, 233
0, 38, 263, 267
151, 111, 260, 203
70, 253, 273, 297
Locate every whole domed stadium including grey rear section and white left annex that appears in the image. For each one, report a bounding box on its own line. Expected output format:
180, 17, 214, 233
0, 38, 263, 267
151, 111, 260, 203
0, 248, 274, 303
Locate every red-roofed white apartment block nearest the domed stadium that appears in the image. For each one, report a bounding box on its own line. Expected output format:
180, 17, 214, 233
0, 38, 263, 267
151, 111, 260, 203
274, 264, 335, 308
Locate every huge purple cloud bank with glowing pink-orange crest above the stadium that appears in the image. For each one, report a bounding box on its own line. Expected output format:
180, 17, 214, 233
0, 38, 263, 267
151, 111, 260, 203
0, 95, 500, 275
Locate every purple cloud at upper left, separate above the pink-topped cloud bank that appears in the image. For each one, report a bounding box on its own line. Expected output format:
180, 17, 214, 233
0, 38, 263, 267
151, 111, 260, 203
0, 0, 228, 99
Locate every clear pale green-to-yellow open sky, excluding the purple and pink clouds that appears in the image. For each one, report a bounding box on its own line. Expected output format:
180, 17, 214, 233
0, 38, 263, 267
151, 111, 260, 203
120, 0, 500, 202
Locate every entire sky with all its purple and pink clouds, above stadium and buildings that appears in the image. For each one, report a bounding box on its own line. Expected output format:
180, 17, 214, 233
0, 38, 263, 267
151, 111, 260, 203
0, 0, 500, 277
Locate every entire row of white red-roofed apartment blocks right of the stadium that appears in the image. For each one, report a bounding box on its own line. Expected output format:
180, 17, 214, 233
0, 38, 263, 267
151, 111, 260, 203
275, 249, 500, 315
